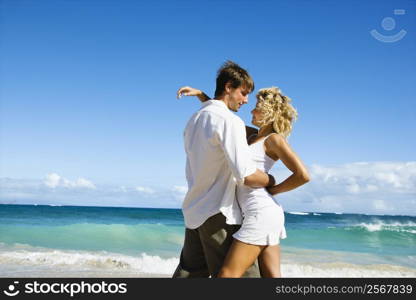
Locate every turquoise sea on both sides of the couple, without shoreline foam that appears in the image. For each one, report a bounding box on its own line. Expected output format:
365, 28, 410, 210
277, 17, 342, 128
0, 205, 416, 276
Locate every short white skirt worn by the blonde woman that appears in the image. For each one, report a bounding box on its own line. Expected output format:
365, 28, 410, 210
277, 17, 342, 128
233, 203, 286, 246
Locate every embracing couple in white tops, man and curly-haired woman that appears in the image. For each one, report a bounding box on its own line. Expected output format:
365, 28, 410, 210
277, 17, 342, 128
173, 61, 309, 278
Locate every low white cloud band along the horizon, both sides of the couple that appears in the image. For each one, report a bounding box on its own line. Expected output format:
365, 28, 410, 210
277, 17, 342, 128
0, 162, 416, 215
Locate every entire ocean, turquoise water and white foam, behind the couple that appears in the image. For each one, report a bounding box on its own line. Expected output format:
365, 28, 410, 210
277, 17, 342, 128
0, 205, 416, 277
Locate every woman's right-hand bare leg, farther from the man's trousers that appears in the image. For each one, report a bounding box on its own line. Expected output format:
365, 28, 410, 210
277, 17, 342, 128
259, 245, 282, 278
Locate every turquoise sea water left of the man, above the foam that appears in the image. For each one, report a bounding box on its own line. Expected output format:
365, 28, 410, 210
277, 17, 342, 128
0, 205, 184, 257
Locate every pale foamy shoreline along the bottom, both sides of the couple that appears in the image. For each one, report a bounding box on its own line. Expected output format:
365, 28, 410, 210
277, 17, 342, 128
0, 244, 416, 278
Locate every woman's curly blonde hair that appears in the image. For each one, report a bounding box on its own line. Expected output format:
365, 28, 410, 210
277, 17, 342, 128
256, 87, 298, 137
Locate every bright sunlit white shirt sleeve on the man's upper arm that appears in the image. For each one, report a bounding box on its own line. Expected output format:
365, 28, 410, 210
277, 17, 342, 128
214, 117, 257, 183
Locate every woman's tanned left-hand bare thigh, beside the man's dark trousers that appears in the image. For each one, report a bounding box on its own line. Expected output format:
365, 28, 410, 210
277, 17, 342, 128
217, 239, 264, 278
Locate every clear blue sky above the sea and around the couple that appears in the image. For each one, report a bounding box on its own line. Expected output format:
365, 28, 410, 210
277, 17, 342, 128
0, 0, 416, 214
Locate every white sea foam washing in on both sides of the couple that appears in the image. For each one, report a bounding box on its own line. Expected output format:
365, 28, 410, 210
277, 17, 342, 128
0, 246, 416, 277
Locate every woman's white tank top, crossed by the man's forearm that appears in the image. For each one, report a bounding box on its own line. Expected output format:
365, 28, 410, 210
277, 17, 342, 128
237, 135, 277, 216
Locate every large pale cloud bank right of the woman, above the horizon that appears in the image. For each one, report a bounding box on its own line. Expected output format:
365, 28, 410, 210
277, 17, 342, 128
276, 162, 416, 215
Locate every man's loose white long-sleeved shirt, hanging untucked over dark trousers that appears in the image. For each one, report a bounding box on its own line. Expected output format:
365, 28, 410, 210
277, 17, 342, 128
182, 100, 256, 229
